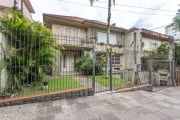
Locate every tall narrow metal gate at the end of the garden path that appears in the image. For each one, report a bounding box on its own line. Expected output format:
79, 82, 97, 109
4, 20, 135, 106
92, 48, 133, 93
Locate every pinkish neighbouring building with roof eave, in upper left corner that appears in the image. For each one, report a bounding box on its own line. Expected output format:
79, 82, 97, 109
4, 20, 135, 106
0, 0, 35, 20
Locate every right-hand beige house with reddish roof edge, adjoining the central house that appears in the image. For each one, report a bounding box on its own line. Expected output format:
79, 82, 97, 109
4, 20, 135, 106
125, 28, 169, 69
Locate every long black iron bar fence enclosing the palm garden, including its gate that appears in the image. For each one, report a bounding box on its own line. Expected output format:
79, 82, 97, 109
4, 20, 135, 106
0, 29, 141, 99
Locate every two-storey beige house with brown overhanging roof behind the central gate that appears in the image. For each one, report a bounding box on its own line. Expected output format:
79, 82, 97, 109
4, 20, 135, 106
43, 14, 127, 74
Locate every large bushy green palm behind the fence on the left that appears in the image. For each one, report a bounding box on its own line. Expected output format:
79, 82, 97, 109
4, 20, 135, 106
0, 10, 60, 91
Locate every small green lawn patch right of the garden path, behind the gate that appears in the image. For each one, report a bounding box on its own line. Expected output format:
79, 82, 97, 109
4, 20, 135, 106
91, 75, 131, 87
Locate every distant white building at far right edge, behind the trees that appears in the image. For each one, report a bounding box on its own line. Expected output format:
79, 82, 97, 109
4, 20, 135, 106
165, 24, 180, 42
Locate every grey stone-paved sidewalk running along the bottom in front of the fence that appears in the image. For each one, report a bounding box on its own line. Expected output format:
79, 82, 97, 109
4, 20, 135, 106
0, 87, 180, 120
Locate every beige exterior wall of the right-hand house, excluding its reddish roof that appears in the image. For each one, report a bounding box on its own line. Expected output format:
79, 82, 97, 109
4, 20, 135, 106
124, 29, 166, 70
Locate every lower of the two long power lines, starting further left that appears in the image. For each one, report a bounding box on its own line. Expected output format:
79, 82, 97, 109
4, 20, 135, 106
60, 0, 174, 16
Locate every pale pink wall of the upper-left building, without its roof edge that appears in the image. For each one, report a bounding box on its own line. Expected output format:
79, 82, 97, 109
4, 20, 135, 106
0, 0, 32, 20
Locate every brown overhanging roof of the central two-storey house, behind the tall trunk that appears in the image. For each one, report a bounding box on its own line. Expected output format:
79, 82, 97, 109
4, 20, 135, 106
43, 13, 127, 32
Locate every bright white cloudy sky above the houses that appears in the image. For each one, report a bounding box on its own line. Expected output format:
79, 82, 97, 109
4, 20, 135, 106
30, 0, 180, 33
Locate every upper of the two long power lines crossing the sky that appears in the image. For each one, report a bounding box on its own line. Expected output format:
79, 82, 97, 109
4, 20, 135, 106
98, 1, 177, 13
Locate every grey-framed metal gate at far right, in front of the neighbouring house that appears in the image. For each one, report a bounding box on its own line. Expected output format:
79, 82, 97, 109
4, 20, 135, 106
148, 60, 175, 91
